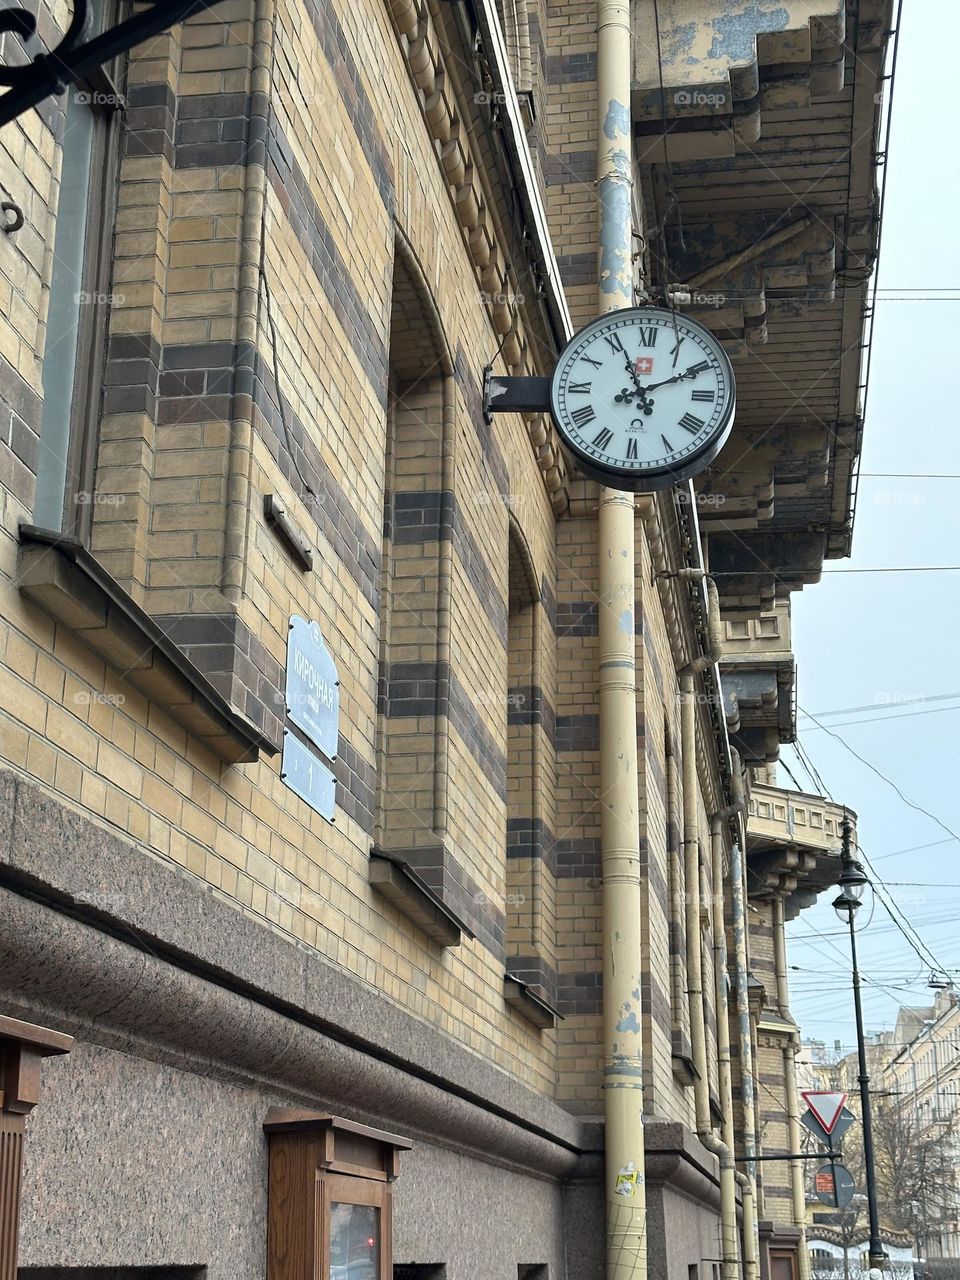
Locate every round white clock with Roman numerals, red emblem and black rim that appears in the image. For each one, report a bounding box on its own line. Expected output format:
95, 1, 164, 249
550, 307, 735, 489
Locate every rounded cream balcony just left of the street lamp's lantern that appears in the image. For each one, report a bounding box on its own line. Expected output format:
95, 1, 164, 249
746, 783, 855, 919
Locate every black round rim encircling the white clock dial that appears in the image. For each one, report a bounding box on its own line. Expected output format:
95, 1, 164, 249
550, 307, 736, 493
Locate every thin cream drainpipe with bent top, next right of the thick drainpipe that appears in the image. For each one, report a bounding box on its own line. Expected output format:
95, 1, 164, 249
676, 568, 740, 1280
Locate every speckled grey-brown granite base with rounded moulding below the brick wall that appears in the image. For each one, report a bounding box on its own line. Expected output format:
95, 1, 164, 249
0, 776, 719, 1280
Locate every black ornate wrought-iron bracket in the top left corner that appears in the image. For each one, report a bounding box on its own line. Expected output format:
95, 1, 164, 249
0, 0, 227, 128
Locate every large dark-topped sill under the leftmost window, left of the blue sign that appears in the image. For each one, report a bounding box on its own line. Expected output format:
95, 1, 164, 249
19, 525, 278, 764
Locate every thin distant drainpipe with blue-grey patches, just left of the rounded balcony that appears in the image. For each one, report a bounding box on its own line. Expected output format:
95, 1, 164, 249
730, 808, 760, 1280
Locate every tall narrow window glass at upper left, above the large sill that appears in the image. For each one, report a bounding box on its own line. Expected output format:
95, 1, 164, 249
33, 0, 122, 540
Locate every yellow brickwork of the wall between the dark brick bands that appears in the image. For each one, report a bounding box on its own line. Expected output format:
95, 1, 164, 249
0, 0, 737, 1123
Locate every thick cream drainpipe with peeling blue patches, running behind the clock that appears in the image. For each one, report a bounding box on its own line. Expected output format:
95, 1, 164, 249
596, 0, 646, 1280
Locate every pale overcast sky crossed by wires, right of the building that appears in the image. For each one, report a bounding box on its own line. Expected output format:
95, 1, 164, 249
781, 0, 960, 1047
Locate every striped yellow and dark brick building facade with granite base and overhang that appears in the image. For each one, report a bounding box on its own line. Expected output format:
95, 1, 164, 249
0, 0, 890, 1280
